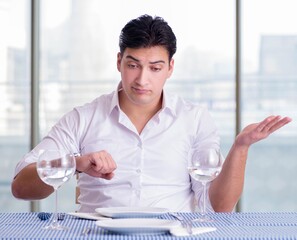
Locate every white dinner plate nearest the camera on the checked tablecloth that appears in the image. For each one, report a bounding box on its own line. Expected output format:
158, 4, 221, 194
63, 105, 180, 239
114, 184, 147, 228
96, 218, 180, 234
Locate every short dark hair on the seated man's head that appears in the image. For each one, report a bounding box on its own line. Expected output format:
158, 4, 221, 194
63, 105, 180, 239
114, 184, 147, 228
119, 15, 176, 61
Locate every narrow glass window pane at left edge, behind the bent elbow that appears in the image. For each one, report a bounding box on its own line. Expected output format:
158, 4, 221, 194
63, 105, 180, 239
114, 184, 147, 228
0, 0, 30, 212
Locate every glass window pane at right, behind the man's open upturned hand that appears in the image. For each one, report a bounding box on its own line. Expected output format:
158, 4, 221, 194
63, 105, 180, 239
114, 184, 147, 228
242, 0, 297, 211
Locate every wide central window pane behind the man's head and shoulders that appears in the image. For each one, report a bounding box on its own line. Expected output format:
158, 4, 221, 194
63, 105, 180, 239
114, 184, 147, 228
40, 0, 235, 210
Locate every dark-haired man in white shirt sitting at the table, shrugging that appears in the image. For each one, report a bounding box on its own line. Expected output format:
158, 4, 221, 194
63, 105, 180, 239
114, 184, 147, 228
12, 15, 291, 212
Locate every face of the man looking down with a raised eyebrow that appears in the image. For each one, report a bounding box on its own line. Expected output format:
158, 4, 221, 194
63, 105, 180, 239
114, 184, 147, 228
117, 46, 174, 106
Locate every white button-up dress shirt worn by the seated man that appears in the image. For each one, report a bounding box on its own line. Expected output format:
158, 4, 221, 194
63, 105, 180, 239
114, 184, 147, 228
15, 87, 219, 212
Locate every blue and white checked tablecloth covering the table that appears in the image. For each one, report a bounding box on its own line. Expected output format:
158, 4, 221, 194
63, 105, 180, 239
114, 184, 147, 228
0, 212, 297, 240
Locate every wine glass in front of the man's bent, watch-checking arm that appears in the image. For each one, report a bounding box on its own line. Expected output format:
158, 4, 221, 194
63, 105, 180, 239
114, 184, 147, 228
36, 149, 76, 230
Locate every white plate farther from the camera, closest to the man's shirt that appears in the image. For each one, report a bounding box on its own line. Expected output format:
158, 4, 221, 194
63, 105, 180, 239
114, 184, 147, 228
95, 207, 168, 218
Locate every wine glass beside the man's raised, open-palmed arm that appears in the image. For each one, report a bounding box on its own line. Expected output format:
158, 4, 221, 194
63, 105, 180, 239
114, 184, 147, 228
188, 148, 224, 222
